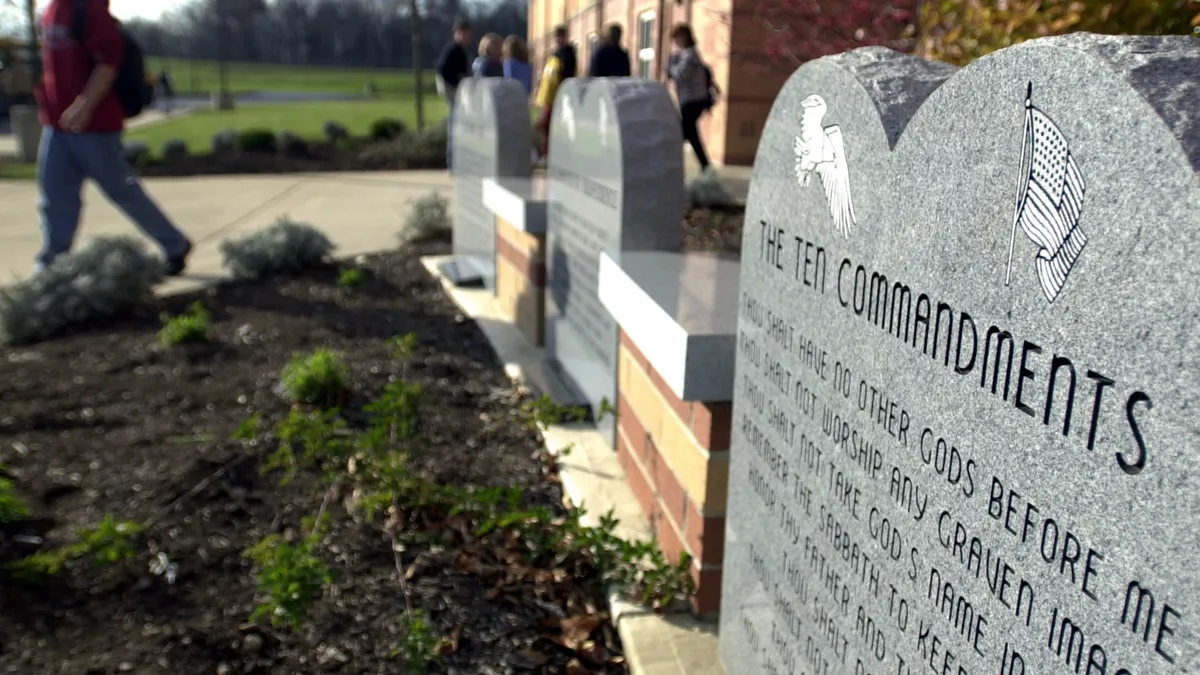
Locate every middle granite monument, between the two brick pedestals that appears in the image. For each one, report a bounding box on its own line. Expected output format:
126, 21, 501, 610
546, 78, 684, 443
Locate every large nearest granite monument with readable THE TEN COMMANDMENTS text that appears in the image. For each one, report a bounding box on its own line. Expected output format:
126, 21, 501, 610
720, 34, 1200, 675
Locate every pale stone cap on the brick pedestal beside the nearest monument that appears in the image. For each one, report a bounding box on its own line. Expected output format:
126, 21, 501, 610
598, 251, 742, 401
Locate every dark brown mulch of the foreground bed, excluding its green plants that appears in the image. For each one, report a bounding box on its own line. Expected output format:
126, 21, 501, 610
0, 243, 625, 675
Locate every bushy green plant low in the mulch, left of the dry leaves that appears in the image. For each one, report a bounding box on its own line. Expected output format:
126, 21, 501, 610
244, 518, 334, 631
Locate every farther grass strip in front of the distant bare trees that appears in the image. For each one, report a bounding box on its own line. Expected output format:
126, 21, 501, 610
146, 56, 437, 100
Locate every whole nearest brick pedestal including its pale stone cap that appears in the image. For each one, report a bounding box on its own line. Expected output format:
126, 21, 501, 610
599, 252, 739, 615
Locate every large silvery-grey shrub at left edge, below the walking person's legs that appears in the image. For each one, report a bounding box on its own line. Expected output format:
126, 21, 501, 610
0, 237, 164, 344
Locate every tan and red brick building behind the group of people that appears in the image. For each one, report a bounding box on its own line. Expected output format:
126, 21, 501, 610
528, 0, 794, 166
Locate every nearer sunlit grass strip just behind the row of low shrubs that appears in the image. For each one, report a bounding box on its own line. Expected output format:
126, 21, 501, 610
125, 97, 446, 154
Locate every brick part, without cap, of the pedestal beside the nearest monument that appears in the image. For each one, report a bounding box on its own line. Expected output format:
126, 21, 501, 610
617, 330, 732, 615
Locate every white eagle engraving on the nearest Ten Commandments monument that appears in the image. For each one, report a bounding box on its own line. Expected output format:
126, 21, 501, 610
793, 94, 858, 238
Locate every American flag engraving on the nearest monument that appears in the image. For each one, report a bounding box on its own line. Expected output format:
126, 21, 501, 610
1004, 83, 1087, 303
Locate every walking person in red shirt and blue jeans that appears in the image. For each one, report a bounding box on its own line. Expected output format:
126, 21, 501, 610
36, 0, 192, 276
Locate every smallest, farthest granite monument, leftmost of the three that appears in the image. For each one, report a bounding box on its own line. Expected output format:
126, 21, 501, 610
444, 77, 533, 288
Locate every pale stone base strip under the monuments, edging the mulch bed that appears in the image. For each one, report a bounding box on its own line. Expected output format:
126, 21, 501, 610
421, 256, 726, 675
